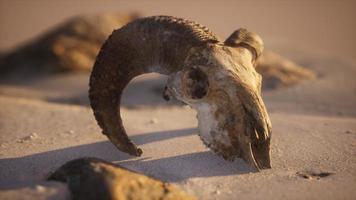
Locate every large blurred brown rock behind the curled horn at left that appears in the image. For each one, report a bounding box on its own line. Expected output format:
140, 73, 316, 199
0, 13, 137, 74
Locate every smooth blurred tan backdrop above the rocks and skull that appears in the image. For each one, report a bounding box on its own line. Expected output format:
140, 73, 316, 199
0, 0, 356, 59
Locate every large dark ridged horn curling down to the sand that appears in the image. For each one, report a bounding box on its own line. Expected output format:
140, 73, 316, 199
89, 16, 218, 156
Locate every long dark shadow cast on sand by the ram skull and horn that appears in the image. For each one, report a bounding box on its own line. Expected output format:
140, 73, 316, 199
0, 128, 251, 189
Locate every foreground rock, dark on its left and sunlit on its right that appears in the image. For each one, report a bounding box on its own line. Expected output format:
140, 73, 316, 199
48, 158, 196, 200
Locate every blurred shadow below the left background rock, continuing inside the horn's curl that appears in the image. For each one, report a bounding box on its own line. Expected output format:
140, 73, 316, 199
0, 73, 182, 108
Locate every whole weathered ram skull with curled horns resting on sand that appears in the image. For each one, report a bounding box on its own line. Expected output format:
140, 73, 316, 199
89, 16, 271, 169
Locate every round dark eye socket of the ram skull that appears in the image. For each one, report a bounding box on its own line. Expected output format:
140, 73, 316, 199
187, 69, 209, 99
